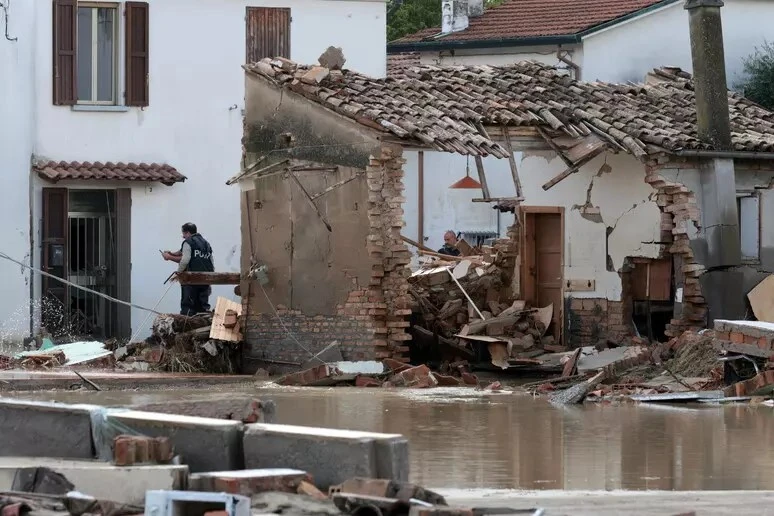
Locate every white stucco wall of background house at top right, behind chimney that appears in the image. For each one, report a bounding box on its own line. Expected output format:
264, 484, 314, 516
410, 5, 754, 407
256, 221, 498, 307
583, 0, 774, 87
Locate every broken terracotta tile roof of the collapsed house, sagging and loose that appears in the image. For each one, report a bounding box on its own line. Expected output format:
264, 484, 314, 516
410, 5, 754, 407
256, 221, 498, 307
245, 59, 774, 159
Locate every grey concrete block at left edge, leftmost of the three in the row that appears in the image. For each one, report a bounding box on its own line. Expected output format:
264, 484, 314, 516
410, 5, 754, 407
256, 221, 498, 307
0, 399, 99, 459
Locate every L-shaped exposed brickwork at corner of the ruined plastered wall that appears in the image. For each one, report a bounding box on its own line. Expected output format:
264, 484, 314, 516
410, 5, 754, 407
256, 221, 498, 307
243, 145, 411, 373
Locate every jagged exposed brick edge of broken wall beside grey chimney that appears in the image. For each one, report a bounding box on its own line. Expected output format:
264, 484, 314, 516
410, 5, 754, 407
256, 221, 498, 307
645, 157, 707, 337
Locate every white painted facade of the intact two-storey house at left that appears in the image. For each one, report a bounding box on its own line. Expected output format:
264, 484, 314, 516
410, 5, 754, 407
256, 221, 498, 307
10, 0, 386, 337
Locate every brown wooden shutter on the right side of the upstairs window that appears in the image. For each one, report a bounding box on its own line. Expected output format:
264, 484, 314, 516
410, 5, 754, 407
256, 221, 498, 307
126, 2, 150, 107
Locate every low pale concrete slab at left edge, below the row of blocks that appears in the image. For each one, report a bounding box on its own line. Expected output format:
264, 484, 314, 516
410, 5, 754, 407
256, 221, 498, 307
0, 457, 188, 505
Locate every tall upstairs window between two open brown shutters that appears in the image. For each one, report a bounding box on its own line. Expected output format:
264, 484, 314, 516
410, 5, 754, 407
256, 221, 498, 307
76, 3, 118, 104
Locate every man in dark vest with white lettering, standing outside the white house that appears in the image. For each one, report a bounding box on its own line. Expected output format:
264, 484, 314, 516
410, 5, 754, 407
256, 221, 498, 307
162, 222, 215, 315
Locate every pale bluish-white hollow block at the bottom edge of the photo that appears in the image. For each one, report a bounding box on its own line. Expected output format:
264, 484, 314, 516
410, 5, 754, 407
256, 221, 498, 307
145, 491, 251, 516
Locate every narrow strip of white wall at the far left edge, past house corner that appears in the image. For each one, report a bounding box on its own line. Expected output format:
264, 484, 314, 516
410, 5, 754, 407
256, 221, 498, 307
0, 1, 35, 346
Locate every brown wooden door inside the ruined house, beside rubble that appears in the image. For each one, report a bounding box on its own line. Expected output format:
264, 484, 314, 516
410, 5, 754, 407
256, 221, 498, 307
522, 208, 564, 342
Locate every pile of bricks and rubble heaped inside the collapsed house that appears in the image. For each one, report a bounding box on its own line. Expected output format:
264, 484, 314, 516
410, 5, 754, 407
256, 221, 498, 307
409, 238, 567, 373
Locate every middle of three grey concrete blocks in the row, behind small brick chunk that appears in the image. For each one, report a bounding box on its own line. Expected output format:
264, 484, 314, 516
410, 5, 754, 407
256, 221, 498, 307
107, 410, 244, 473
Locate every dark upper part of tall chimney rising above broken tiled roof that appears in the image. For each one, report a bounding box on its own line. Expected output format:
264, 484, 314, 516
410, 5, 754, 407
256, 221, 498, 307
685, 0, 731, 150
